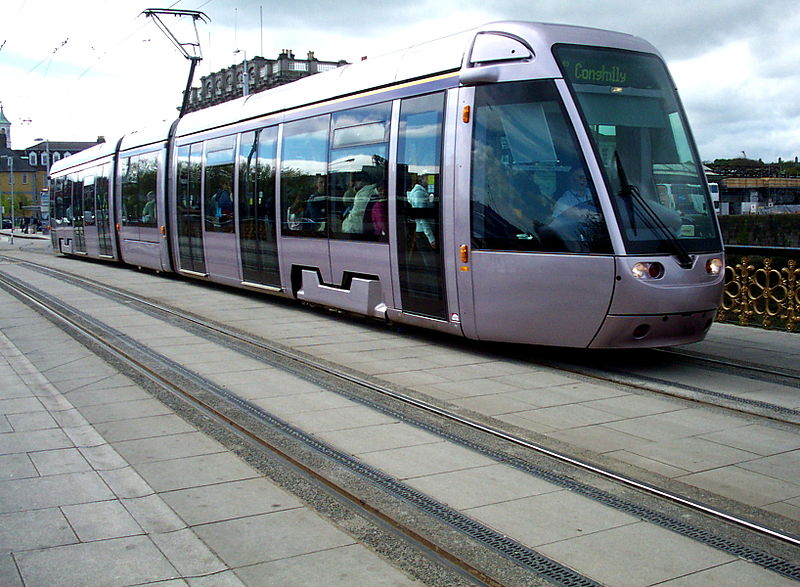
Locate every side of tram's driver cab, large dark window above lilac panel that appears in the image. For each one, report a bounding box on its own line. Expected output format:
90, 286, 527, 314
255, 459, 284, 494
453, 81, 614, 346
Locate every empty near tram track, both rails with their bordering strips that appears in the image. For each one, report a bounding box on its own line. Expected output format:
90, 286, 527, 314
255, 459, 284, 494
2, 255, 800, 585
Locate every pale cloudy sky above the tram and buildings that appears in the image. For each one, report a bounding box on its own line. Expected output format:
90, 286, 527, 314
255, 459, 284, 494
0, 0, 800, 162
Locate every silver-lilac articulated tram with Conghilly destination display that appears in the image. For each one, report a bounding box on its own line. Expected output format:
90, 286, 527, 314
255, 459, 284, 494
51, 22, 724, 348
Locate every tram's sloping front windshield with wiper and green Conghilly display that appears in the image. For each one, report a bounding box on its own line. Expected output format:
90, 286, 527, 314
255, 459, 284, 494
554, 45, 720, 261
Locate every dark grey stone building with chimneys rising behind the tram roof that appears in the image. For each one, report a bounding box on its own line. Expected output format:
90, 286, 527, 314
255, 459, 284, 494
186, 49, 347, 112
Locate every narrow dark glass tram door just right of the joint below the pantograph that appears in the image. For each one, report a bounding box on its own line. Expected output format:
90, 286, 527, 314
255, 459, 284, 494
176, 143, 206, 275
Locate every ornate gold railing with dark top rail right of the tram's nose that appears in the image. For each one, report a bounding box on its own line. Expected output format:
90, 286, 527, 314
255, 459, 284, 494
717, 247, 800, 332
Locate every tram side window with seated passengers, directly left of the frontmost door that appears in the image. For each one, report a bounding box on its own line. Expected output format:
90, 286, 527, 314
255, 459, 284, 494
328, 102, 392, 242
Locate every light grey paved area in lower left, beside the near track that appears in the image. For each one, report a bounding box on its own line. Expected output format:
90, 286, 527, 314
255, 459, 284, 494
0, 293, 422, 587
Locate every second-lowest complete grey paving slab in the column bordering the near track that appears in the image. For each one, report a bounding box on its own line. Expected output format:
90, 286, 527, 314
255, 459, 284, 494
161, 478, 303, 526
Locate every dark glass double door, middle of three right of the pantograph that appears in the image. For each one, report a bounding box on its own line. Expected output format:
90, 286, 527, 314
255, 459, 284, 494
237, 127, 281, 288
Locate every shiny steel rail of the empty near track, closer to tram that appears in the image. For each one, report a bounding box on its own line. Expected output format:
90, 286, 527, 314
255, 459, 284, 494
6, 261, 800, 547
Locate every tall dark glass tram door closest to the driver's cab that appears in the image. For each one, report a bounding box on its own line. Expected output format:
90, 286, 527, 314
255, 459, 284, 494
395, 92, 447, 320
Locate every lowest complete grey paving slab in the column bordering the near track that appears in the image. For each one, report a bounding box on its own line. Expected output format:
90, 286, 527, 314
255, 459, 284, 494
195, 509, 354, 568
